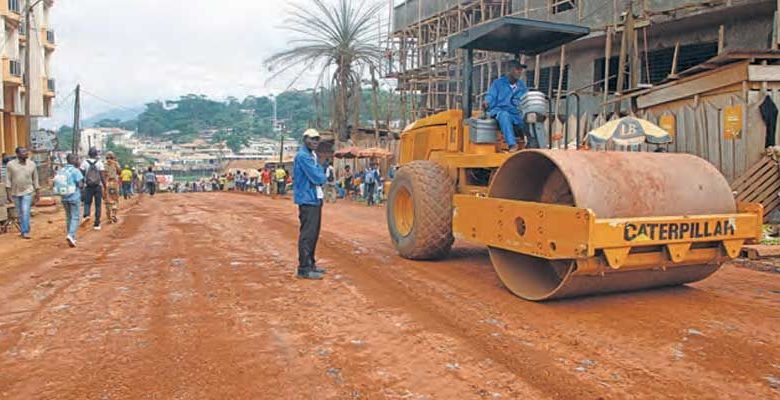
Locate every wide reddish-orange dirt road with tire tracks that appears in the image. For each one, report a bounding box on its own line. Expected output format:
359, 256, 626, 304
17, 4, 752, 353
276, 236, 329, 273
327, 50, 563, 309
0, 193, 780, 399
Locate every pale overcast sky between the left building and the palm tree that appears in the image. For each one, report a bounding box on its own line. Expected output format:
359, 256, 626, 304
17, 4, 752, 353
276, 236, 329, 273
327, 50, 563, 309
47, 0, 346, 126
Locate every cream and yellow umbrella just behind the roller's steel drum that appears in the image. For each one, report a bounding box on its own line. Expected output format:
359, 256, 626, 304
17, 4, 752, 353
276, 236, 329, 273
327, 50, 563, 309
588, 117, 672, 146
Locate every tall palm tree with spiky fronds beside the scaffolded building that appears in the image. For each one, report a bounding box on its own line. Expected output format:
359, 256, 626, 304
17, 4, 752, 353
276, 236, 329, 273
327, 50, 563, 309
266, 0, 382, 142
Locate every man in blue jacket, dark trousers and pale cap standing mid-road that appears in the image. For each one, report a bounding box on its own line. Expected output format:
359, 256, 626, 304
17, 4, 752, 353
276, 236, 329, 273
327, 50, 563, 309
293, 129, 327, 279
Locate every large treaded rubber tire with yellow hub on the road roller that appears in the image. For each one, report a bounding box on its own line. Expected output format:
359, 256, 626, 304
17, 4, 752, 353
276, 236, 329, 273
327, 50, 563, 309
387, 161, 455, 260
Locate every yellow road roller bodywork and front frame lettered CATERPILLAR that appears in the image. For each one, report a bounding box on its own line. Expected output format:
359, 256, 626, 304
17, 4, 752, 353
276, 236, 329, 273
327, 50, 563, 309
399, 110, 763, 274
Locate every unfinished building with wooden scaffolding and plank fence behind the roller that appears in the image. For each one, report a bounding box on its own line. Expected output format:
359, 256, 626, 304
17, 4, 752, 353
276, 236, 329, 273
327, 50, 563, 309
387, 0, 780, 219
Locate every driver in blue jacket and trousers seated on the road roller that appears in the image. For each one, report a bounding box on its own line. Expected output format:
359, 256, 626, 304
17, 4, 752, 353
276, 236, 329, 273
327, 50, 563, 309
482, 60, 528, 151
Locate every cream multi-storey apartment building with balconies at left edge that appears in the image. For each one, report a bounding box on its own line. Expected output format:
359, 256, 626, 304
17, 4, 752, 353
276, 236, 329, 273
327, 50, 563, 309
0, 0, 56, 154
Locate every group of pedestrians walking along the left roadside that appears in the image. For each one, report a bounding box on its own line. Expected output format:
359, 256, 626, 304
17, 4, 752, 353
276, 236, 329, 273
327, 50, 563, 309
5, 147, 157, 247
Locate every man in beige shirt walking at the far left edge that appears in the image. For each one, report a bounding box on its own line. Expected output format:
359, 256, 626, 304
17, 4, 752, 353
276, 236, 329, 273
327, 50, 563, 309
5, 147, 41, 239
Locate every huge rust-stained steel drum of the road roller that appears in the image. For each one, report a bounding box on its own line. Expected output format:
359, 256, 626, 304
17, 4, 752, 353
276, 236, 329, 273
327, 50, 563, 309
489, 150, 737, 300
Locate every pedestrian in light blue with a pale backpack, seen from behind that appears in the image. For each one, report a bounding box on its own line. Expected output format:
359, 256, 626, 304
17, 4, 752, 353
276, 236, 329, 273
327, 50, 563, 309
54, 154, 84, 247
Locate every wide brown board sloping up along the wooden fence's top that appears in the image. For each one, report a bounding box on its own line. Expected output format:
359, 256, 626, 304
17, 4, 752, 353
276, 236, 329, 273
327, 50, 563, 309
636, 62, 748, 108
